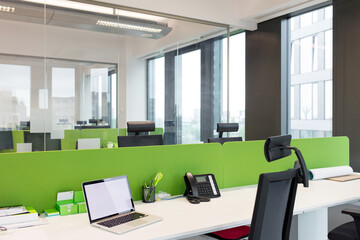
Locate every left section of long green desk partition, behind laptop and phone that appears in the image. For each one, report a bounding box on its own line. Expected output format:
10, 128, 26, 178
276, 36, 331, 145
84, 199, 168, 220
0, 144, 222, 211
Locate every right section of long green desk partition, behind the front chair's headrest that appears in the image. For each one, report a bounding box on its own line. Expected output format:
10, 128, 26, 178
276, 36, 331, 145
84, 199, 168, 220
223, 137, 349, 188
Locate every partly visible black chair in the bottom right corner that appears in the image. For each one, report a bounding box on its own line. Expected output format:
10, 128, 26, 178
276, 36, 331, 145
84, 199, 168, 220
328, 209, 360, 240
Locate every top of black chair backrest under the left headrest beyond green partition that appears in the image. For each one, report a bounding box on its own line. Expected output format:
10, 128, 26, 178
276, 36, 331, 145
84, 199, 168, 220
118, 135, 163, 147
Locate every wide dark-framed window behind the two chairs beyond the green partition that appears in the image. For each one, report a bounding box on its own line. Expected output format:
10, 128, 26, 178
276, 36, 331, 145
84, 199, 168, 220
147, 33, 245, 144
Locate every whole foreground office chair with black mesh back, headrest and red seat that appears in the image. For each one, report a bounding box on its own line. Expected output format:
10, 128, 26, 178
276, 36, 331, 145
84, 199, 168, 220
209, 135, 309, 240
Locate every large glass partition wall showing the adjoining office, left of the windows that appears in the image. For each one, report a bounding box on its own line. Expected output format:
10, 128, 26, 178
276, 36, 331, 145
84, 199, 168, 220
0, 0, 227, 152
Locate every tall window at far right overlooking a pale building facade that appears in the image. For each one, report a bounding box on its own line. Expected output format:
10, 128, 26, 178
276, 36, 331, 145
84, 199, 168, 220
288, 6, 332, 138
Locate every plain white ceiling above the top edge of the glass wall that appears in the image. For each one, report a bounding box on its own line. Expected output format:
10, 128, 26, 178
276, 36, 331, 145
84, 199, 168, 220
94, 0, 326, 30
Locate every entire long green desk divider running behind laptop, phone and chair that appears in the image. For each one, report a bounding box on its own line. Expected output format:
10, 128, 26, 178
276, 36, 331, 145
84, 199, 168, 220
0, 137, 349, 212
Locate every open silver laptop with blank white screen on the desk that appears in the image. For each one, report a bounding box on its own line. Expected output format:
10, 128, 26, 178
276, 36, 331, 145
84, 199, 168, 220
82, 176, 162, 234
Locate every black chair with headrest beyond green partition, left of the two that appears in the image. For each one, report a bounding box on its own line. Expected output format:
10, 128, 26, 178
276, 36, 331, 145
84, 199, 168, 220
118, 121, 163, 147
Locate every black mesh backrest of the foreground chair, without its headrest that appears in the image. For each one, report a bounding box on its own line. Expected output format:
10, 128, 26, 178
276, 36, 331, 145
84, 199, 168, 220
249, 168, 300, 240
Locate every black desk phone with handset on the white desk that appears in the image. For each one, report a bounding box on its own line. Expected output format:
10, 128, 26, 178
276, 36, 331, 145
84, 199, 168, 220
184, 172, 221, 204
